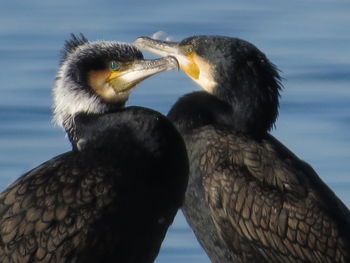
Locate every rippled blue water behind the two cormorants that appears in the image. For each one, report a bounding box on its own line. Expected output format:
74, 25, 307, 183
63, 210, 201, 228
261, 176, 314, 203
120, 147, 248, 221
0, 0, 350, 263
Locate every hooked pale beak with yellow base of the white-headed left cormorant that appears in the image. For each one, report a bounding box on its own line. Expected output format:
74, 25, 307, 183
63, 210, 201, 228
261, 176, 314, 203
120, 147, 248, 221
107, 56, 179, 93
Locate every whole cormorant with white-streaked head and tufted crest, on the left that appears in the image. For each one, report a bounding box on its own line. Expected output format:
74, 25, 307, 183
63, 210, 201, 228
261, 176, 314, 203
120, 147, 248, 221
0, 35, 188, 263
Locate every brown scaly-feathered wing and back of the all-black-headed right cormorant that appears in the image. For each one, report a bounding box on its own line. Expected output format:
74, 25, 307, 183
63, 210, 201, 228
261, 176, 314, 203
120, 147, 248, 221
193, 127, 350, 263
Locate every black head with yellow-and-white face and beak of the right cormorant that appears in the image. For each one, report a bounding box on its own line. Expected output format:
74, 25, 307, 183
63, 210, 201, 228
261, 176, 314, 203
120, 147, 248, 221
134, 36, 281, 134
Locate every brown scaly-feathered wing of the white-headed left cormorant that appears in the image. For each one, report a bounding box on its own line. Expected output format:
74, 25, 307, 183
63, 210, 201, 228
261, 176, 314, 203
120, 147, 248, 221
0, 153, 115, 263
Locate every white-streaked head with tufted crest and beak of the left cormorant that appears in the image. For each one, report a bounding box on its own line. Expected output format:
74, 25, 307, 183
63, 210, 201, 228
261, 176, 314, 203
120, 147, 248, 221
53, 35, 178, 130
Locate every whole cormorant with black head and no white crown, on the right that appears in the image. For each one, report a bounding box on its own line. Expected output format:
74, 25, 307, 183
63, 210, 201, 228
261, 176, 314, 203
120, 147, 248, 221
134, 36, 350, 263
